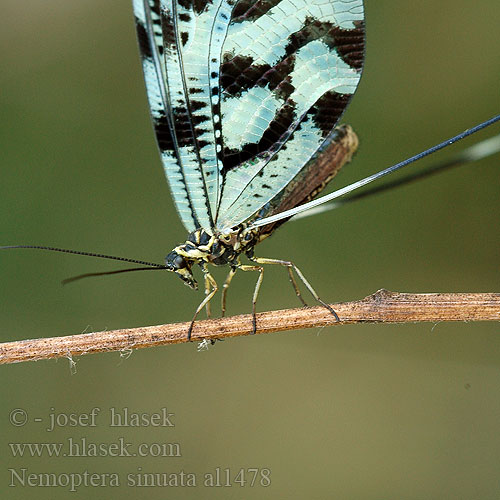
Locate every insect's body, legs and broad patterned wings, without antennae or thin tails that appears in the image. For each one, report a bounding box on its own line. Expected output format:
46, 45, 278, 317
134, 0, 364, 336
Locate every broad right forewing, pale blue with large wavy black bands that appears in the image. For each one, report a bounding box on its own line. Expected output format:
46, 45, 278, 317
216, 0, 364, 229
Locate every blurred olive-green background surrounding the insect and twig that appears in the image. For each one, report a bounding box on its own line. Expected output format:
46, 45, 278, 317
0, 0, 500, 499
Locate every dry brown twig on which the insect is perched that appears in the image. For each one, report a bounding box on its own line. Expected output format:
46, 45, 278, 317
0, 290, 500, 364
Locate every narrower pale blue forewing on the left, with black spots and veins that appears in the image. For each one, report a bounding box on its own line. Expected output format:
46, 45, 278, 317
134, 0, 230, 231
